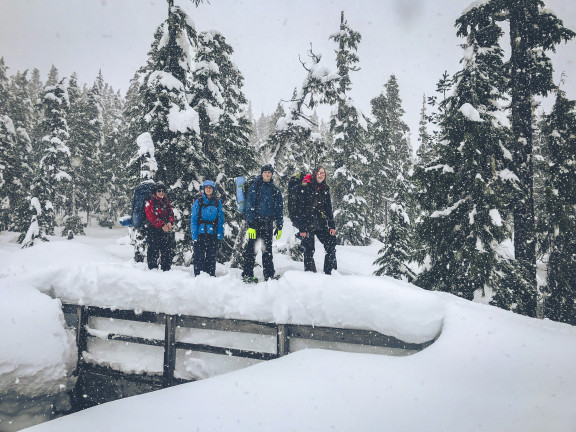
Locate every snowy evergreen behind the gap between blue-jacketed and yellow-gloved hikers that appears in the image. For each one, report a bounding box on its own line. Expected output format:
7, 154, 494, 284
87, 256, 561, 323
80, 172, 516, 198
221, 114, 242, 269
191, 31, 256, 261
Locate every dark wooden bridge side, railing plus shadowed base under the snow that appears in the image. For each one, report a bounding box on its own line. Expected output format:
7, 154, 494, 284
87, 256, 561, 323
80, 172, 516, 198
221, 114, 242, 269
62, 304, 434, 409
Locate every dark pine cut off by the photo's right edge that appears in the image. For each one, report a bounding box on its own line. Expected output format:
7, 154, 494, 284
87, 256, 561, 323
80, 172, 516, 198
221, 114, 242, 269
543, 90, 576, 325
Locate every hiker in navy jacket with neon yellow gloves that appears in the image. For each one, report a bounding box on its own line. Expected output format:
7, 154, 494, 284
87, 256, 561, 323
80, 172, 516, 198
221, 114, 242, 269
242, 165, 284, 283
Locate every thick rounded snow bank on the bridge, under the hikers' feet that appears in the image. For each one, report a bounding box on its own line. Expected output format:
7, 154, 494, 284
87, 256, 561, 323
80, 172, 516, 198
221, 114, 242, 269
18, 263, 444, 343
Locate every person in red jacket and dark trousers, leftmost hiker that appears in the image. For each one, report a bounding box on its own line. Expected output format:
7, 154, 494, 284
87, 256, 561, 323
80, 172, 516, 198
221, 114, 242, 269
144, 182, 174, 271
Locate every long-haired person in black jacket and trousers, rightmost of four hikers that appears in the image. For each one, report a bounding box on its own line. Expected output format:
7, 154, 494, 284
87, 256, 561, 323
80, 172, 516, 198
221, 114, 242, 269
298, 166, 337, 274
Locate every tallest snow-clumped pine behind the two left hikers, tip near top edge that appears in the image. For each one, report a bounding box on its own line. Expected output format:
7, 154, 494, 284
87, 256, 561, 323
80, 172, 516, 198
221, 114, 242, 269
138, 6, 205, 265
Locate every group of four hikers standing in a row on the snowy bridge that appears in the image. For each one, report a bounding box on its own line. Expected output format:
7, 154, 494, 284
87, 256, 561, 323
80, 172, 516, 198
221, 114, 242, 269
145, 165, 337, 283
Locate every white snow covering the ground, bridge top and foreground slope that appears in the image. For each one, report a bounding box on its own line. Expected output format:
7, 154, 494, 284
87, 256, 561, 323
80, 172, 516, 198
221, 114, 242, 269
0, 228, 576, 432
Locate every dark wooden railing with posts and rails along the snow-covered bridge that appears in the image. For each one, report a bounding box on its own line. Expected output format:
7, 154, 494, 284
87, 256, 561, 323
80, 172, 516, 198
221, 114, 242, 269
62, 304, 434, 404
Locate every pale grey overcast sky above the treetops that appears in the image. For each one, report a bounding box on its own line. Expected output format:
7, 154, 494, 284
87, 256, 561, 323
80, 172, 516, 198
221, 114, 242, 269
0, 0, 576, 144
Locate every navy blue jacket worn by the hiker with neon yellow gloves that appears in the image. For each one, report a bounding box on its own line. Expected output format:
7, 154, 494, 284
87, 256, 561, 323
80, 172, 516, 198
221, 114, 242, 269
246, 177, 284, 230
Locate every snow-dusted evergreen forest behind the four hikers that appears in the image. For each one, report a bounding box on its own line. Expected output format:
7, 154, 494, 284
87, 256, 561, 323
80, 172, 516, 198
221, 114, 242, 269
0, 0, 576, 324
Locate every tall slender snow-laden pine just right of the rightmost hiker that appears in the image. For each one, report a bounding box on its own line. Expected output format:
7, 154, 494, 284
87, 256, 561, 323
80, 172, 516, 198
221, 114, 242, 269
330, 13, 370, 245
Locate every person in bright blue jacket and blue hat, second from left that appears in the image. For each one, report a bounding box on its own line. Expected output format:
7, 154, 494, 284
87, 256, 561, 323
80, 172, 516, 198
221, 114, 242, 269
190, 180, 224, 276
